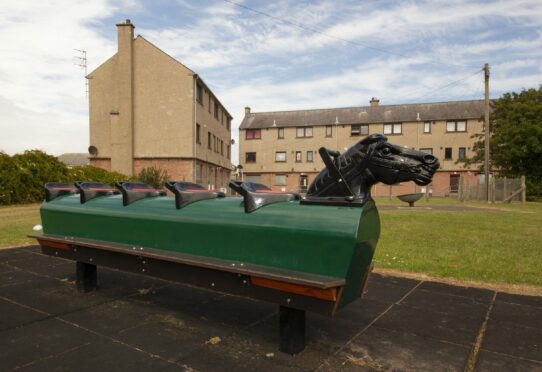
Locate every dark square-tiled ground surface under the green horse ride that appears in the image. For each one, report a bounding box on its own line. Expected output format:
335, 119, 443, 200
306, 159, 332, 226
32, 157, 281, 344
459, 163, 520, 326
0, 247, 542, 371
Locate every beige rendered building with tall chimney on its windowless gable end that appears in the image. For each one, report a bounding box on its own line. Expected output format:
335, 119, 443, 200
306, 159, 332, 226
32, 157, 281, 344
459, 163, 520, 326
87, 20, 232, 188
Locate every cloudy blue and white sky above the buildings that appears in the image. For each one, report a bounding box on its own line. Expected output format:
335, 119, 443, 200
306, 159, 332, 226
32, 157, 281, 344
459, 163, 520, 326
0, 0, 542, 163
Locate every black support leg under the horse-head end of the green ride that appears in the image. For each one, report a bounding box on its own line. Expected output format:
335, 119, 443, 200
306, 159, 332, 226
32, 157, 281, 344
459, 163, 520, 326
280, 306, 305, 355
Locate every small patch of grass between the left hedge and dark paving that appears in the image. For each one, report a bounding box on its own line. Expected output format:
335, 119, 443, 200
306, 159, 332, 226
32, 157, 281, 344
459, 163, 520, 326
0, 204, 40, 248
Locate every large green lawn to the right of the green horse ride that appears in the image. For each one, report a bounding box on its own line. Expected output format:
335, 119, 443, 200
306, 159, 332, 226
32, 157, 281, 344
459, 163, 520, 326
375, 199, 542, 286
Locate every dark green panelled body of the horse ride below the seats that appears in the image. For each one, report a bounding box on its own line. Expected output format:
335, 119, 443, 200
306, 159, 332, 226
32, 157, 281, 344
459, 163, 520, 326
41, 195, 380, 305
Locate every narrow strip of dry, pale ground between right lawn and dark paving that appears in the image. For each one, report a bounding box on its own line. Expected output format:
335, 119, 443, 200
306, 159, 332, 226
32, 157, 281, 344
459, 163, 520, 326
373, 267, 542, 296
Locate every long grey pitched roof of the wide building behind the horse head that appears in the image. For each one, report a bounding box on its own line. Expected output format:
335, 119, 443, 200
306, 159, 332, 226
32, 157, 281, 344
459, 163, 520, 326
239, 100, 484, 129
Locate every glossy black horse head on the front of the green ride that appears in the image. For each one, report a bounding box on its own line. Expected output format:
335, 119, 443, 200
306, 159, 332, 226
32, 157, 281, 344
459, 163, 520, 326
302, 134, 439, 204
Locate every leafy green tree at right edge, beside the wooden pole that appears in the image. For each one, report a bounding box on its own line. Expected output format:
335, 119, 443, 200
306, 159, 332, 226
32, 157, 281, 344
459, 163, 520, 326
465, 86, 542, 200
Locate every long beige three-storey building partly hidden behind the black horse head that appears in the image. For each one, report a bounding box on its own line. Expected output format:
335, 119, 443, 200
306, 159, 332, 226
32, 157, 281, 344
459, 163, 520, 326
239, 98, 484, 196
